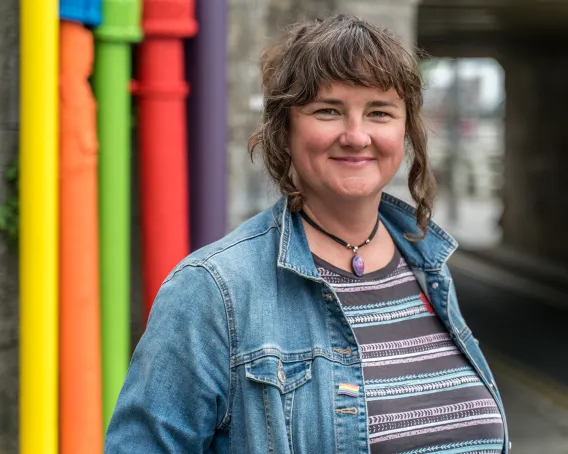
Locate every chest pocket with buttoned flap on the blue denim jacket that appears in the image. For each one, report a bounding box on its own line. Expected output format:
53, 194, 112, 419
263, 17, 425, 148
245, 356, 312, 454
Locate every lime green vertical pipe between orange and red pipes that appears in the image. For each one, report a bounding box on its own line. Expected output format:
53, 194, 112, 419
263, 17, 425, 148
93, 0, 141, 428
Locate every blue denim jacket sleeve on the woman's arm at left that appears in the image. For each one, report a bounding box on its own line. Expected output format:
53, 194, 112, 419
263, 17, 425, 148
104, 265, 230, 454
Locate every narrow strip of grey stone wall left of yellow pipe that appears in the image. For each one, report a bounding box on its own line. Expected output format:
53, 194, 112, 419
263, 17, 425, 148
0, 0, 19, 454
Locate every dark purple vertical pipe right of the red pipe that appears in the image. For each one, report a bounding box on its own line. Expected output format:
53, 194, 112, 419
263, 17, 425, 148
186, 0, 228, 250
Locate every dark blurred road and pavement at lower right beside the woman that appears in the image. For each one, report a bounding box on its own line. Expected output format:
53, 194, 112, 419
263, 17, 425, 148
450, 252, 568, 454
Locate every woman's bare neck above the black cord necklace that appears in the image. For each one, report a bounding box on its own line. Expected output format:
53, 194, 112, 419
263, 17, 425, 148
304, 193, 380, 245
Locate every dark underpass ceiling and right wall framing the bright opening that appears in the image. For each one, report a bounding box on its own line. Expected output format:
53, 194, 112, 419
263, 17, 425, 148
418, 0, 568, 266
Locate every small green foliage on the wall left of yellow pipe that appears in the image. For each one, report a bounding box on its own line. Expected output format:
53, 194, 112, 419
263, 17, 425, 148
0, 156, 20, 250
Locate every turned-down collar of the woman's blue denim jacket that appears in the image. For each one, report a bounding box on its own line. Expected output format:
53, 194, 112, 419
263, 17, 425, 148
272, 192, 458, 281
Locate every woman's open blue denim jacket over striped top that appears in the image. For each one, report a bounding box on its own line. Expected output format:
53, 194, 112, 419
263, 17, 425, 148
105, 194, 509, 454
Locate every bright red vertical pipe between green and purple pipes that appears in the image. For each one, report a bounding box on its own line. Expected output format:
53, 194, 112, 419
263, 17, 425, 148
134, 0, 197, 320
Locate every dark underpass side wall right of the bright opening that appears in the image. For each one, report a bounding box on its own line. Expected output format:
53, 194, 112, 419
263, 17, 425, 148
501, 43, 568, 265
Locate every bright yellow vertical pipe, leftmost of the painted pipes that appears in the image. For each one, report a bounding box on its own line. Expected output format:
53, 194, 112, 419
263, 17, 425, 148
20, 0, 59, 454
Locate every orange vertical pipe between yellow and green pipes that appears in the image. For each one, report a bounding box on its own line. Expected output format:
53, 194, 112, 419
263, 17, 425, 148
59, 21, 103, 454
